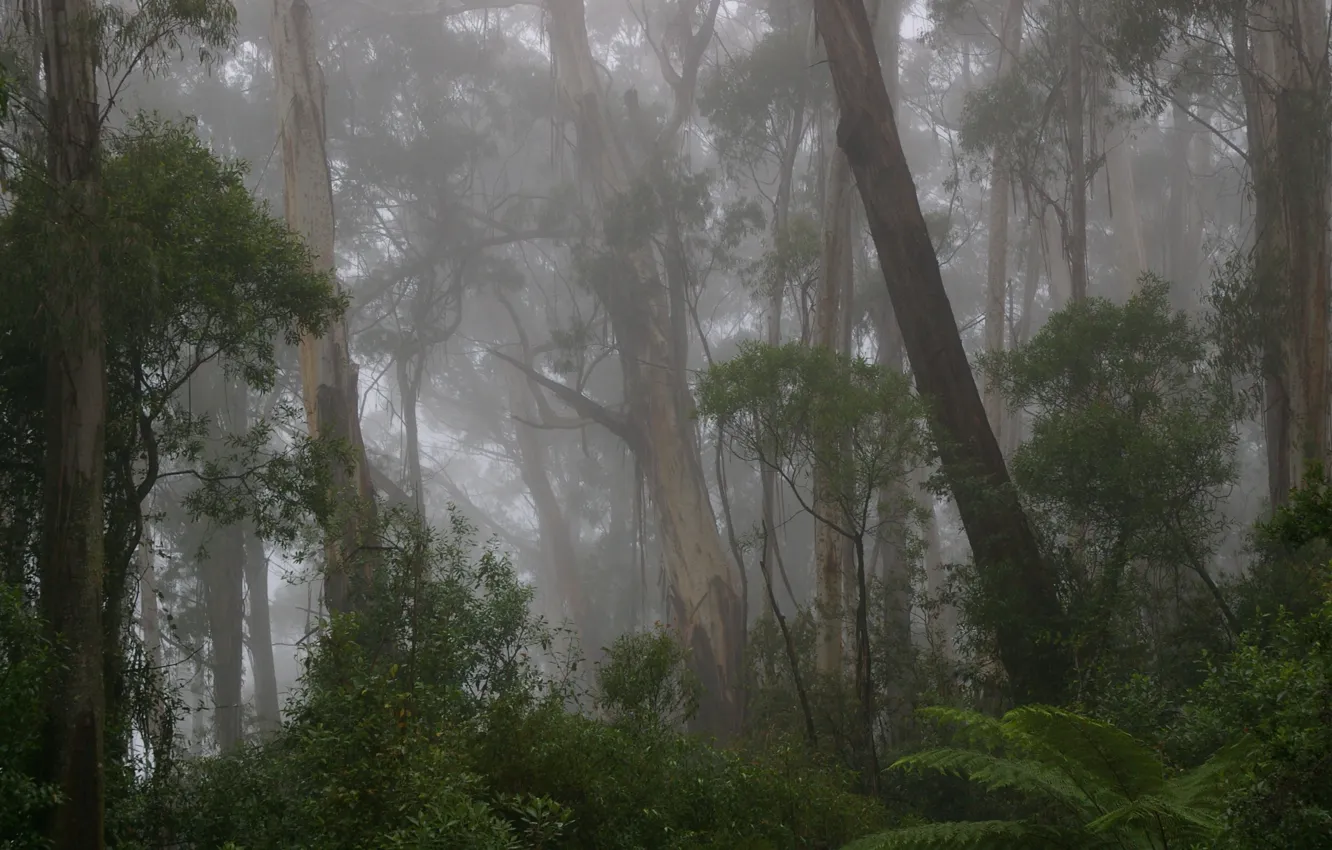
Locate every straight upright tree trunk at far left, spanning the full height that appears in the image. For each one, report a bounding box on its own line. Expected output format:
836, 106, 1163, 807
39, 0, 107, 850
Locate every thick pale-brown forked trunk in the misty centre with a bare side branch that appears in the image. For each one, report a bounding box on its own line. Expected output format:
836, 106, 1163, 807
546, 0, 745, 739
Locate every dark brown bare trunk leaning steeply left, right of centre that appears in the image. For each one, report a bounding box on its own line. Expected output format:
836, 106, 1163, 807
814, 0, 1071, 702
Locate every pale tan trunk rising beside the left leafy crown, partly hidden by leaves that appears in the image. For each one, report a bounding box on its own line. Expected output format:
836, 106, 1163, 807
272, 0, 374, 613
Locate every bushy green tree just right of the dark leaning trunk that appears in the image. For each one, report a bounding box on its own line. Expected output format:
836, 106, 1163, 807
986, 278, 1237, 695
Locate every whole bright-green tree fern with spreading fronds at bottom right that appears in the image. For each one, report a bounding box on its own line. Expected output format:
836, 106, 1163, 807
848, 706, 1236, 850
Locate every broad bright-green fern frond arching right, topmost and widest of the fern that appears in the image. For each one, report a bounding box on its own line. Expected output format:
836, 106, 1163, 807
1003, 705, 1166, 799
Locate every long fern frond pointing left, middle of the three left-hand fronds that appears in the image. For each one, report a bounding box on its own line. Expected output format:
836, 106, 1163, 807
892, 747, 1124, 817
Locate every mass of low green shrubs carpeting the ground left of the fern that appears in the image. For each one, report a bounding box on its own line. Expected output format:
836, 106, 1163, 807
155, 514, 883, 850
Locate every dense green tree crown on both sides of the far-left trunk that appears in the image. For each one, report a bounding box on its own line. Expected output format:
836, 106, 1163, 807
0, 117, 345, 580
